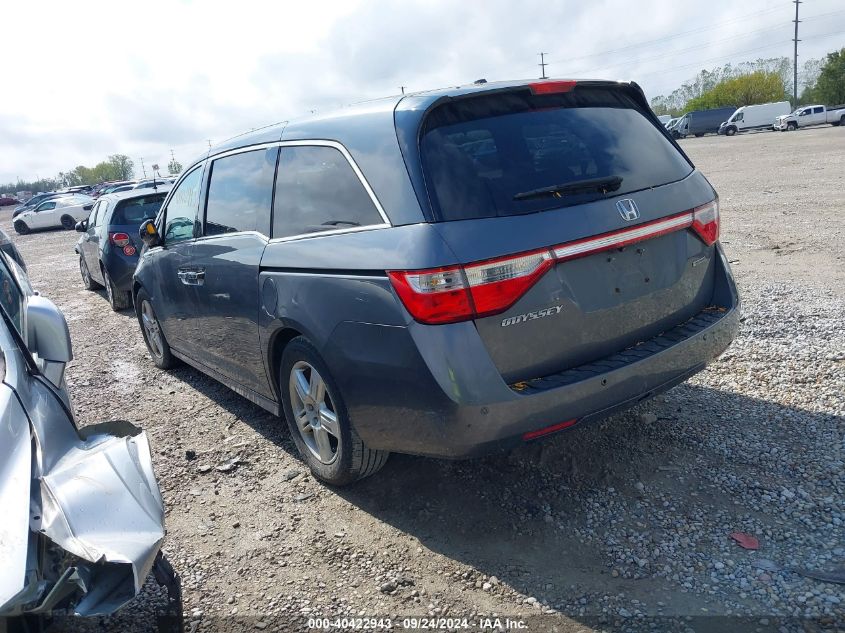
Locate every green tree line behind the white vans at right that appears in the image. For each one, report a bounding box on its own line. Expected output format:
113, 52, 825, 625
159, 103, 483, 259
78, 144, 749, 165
651, 48, 845, 116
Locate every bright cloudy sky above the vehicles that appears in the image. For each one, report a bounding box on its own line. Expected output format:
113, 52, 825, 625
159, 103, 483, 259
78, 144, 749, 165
0, 0, 845, 183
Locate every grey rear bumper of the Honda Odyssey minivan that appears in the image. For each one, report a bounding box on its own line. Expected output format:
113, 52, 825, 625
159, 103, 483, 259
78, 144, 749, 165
326, 244, 740, 458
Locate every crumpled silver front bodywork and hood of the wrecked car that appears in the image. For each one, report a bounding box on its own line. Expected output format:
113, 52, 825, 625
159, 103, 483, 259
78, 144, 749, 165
0, 384, 165, 615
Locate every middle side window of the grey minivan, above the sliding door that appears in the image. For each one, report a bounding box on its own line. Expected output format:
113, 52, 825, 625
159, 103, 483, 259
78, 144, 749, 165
204, 147, 279, 236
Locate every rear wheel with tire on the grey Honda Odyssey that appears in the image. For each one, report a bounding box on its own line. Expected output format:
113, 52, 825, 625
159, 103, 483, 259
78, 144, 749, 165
279, 336, 390, 486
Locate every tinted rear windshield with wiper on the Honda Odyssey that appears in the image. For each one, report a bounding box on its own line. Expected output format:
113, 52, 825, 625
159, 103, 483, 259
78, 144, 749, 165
421, 87, 692, 221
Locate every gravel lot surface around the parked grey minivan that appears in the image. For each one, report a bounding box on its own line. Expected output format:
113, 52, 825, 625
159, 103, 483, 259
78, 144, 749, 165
0, 127, 845, 632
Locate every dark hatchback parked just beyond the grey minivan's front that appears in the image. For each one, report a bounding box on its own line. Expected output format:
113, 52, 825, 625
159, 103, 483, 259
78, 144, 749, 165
75, 187, 170, 311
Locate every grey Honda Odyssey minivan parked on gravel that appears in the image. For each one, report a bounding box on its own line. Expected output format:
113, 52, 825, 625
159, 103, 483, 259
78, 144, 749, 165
133, 81, 739, 484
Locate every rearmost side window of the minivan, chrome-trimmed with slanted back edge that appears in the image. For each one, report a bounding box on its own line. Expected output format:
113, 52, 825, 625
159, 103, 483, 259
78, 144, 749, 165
273, 145, 384, 237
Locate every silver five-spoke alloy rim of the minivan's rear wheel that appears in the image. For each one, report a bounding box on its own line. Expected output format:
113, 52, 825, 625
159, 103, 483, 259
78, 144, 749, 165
289, 360, 341, 464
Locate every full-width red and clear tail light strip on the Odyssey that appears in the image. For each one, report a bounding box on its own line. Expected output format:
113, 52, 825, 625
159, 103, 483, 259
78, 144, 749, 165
387, 199, 719, 325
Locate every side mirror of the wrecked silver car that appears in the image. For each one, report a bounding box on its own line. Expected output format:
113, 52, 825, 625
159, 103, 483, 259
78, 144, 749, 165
26, 295, 73, 388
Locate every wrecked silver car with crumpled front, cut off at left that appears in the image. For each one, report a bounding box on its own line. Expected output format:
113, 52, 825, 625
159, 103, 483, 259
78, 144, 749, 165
0, 255, 170, 630
